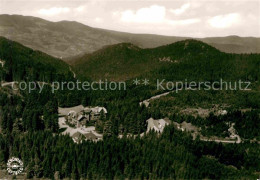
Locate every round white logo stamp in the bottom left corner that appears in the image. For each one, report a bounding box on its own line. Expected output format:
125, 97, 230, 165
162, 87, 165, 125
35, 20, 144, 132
7, 157, 23, 175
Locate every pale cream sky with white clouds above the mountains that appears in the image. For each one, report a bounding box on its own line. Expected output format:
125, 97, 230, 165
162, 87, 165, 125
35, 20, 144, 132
0, 0, 260, 37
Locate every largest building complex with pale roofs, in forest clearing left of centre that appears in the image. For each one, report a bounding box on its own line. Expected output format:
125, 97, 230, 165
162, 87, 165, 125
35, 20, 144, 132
59, 105, 107, 127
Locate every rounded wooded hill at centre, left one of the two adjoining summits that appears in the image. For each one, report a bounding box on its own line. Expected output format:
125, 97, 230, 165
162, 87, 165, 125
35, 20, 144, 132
71, 43, 160, 80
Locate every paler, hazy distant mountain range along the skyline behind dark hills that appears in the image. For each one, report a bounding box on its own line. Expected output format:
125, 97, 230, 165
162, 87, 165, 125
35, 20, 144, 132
0, 15, 260, 60
